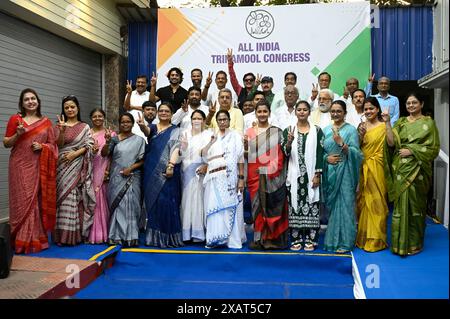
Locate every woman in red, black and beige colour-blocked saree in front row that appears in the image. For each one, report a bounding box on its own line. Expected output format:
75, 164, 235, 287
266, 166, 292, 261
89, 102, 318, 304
244, 101, 289, 249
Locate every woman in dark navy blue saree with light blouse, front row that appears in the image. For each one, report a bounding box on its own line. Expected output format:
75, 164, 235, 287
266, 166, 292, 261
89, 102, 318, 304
142, 103, 184, 248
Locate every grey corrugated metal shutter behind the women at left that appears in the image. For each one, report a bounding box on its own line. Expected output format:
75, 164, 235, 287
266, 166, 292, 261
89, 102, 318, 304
0, 12, 102, 221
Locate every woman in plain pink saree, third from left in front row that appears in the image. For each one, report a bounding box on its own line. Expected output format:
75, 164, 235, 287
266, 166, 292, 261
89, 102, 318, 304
89, 108, 116, 244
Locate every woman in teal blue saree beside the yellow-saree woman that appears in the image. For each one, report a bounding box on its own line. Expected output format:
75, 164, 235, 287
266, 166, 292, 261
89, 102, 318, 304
322, 100, 362, 253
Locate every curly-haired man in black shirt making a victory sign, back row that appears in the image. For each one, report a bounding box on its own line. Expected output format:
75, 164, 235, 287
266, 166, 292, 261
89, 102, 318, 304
150, 67, 188, 113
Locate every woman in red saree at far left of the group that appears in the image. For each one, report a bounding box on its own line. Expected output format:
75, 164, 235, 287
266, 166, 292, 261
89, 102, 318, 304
3, 89, 58, 254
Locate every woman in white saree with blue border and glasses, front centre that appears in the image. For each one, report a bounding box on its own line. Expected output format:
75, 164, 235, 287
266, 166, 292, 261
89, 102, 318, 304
201, 110, 247, 249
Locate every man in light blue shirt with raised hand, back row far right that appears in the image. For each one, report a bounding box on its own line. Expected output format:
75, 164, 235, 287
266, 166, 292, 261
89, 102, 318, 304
364, 74, 400, 126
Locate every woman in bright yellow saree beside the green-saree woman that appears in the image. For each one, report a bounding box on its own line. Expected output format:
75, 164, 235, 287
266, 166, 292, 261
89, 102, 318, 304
356, 97, 389, 252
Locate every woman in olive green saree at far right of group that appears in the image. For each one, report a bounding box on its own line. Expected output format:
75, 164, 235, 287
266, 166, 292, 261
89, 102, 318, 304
382, 93, 440, 256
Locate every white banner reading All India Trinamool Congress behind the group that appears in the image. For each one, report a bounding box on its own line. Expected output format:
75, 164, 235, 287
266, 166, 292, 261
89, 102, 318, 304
157, 1, 371, 97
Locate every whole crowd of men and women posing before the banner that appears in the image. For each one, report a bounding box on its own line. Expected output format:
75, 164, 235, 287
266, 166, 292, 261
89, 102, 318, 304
4, 61, 439, 256
